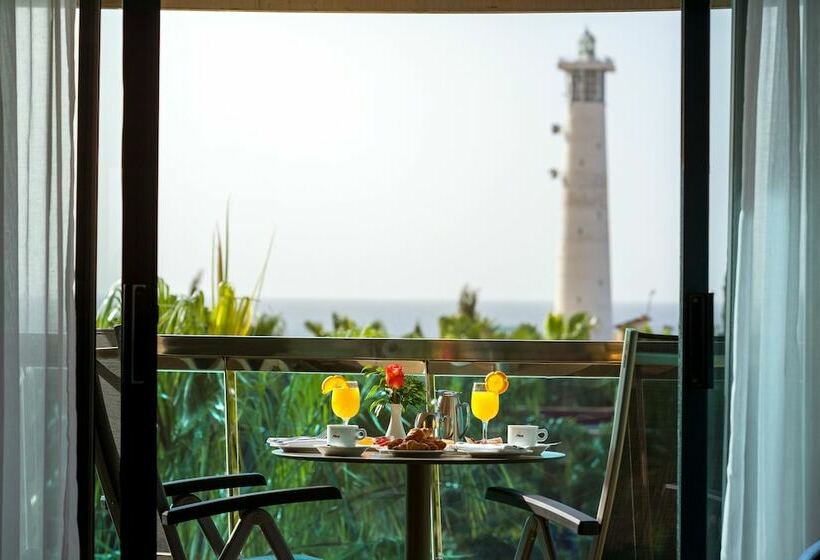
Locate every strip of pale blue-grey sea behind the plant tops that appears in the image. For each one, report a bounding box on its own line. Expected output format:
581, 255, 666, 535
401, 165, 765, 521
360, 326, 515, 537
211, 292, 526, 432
257, 299, 678, 338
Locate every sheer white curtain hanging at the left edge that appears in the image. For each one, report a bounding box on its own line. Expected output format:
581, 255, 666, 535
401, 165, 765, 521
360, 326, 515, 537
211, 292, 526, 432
0, 0, 79, 560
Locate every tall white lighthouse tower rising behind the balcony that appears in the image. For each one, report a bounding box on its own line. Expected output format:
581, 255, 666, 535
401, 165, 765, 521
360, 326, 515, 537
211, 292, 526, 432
554, 31, 615, 339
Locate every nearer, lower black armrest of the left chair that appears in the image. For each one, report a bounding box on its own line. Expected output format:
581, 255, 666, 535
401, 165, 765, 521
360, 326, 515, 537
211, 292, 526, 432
162, 486, 342, 525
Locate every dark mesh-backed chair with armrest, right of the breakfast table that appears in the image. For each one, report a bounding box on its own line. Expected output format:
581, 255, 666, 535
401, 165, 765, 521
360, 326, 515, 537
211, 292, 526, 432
487, 329, 677, 560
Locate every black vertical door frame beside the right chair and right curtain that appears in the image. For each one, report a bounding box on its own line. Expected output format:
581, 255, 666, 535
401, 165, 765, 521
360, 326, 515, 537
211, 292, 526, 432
677, 0, 714, 560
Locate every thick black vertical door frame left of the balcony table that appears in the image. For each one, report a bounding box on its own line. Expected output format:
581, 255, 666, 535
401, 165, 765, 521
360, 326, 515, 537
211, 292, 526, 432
120, 0, 160, 560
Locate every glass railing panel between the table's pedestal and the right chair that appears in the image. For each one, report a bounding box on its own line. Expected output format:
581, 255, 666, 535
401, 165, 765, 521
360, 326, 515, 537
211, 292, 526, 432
436, 374, 617, 558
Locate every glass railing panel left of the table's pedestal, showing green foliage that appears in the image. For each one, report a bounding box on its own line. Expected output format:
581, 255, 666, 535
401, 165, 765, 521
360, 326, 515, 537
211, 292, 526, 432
237, 371, 405, 559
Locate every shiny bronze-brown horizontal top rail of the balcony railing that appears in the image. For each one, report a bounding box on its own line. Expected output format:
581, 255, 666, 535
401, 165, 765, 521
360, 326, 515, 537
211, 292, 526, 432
97, 331, 677, 377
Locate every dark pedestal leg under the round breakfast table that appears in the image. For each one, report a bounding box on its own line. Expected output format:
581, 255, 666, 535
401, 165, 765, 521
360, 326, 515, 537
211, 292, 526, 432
404, 463, 433, 560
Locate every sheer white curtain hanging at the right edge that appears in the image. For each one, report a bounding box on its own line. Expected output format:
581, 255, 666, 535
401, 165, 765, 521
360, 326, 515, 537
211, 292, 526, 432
722, 0, 820, 560
